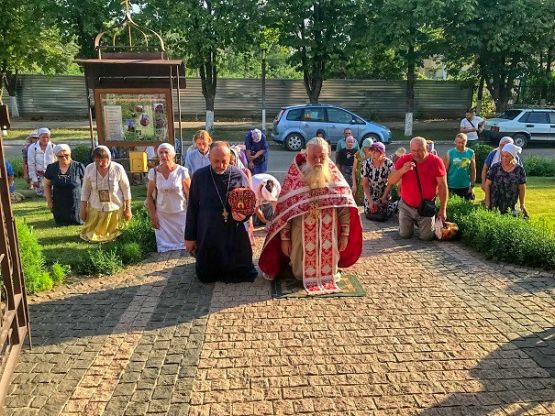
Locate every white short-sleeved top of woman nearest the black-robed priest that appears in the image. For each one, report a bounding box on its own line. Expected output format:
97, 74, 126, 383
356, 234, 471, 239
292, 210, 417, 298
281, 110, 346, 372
148, 165, 189, 214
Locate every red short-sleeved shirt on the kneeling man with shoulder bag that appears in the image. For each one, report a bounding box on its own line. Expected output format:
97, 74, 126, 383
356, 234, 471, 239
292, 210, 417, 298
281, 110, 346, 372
395, 153, 446, 208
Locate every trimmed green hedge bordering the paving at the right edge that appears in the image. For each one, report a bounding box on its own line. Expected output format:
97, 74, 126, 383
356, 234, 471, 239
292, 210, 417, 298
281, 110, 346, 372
448, 197, 555, 270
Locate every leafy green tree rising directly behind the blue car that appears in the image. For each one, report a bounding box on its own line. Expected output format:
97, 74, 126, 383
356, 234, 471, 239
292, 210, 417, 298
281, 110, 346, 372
267, 0, 357, 103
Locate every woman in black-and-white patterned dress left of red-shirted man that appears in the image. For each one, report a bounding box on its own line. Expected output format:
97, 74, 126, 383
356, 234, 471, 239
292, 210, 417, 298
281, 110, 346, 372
362, 142, 395, 219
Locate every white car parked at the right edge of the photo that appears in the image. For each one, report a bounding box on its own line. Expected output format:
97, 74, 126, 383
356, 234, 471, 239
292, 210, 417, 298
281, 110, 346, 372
483, 108, 555, 147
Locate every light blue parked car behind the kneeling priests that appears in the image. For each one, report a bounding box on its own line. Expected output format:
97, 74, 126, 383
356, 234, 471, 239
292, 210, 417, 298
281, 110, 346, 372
272, 104, 391, 151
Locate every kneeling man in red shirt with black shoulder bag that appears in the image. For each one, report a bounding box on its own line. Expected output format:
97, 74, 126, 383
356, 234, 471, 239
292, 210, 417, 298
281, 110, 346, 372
388, 137, 449, 240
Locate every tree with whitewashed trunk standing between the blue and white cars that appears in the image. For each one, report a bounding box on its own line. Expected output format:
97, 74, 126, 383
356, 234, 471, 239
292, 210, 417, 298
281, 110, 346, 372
365, 0, 443, 136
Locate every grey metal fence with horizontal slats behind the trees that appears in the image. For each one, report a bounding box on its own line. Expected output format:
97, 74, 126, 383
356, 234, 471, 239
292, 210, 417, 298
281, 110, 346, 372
17, 75, 472, 119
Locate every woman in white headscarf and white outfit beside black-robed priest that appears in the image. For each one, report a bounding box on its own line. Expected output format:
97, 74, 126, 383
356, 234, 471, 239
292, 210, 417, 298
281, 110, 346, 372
146, 143, 191, 253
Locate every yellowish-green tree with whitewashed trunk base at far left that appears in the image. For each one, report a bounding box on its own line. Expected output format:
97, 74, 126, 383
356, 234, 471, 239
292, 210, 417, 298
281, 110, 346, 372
0, 0, 77, 117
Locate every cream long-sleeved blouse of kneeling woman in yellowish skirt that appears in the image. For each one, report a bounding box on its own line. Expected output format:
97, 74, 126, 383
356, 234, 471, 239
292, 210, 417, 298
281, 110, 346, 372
81, 162, 131, 211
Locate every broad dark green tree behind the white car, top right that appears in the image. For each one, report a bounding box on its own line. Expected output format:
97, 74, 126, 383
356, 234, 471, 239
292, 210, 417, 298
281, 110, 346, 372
443, 0, 554, 112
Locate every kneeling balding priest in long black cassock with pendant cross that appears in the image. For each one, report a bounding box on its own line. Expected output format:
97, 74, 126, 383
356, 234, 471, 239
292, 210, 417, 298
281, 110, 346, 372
185, 141, 258, 283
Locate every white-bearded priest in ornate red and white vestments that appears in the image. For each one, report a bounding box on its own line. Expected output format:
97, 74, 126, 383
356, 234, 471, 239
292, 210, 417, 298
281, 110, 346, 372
259, 137, 362, 295
